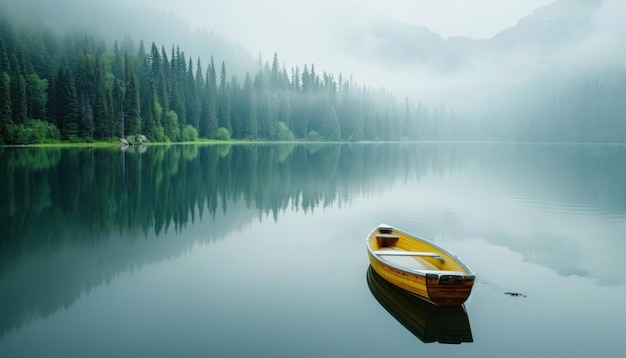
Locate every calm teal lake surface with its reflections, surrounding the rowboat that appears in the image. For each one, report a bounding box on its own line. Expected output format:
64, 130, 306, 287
0, 144, 626, 358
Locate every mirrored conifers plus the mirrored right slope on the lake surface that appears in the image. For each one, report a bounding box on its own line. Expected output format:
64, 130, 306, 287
0, 144, 626, 257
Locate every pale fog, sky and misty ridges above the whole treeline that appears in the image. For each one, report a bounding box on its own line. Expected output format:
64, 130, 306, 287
0, 0, 626, 117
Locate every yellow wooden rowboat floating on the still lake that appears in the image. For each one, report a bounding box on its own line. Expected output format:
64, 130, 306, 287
367, 224, 476, 307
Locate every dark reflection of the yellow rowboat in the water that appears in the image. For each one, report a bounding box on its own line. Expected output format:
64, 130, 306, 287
367, 266, 474, 344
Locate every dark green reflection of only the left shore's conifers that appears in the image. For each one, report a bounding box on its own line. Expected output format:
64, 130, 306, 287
0, 145, 464, 257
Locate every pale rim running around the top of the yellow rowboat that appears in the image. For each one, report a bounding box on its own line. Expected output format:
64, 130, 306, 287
366, 224, 476, 280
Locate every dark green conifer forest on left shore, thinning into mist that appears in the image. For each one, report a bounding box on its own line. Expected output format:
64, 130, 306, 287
0, 19, 464, 144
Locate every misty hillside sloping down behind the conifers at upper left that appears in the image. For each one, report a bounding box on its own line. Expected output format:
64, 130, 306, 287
0, 0, 257, 76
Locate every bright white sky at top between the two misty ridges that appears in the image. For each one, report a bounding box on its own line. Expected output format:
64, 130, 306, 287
142, 0, 553, 60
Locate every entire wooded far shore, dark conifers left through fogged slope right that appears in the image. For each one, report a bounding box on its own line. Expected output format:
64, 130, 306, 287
0, 16, 626, 145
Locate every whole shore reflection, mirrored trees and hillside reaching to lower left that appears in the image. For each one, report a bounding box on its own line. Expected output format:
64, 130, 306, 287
0, 143, 626, 336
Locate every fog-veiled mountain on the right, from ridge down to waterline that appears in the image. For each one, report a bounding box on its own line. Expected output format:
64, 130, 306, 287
330, 0, 626, 143
